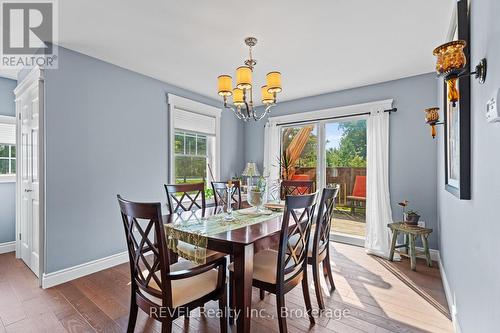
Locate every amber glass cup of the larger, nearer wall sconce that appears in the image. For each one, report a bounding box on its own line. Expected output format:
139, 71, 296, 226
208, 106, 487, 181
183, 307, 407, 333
432, 40, 467, 74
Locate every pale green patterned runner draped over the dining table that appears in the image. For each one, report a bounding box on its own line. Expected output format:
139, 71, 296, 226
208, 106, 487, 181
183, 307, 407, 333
164, 208, 283, 264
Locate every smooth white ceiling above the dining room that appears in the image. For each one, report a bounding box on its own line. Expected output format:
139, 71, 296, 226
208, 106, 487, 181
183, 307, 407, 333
55, 0, 455, 100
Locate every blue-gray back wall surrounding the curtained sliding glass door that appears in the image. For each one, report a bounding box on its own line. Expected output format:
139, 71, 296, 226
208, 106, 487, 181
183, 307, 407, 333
244, 73, 438, 249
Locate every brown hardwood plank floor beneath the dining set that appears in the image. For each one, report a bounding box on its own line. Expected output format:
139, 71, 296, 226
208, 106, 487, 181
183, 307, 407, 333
0, 243, 453, 333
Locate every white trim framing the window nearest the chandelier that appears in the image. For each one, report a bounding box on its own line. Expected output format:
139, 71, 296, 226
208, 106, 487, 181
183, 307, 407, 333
167, 94, 221, 183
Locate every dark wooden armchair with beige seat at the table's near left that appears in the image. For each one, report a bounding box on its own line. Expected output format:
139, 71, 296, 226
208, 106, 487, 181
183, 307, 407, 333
118, 195, 227, 333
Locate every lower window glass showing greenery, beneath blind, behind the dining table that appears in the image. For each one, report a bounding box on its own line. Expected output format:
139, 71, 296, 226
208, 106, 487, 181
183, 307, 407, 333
174, 131, 214, 184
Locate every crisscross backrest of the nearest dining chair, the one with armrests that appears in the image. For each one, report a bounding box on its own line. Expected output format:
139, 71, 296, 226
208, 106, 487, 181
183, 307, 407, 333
117, 195, 172, 306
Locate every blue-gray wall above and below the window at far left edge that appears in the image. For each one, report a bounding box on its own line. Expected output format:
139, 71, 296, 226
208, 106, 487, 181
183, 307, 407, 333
0, 77, 17, 244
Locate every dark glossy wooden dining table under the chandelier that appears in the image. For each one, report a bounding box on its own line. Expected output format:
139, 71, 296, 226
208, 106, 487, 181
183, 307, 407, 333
162, 207, 283, 333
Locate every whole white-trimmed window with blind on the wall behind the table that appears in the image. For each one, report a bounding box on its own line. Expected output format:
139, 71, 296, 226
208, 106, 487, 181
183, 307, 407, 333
168, 94, 220, 188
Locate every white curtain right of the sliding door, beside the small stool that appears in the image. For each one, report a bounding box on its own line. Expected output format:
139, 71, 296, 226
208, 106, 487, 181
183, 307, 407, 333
365, 108, 399, 259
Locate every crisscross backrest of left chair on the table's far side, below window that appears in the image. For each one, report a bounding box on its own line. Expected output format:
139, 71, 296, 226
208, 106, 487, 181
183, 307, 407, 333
165, 183, 206, 214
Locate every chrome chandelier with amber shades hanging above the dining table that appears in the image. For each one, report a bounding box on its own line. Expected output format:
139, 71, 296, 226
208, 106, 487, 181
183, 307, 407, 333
218, 37, 281, 121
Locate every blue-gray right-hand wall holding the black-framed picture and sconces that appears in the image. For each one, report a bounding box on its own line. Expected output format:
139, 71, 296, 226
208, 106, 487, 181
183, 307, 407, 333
437, 0, 500, 333
